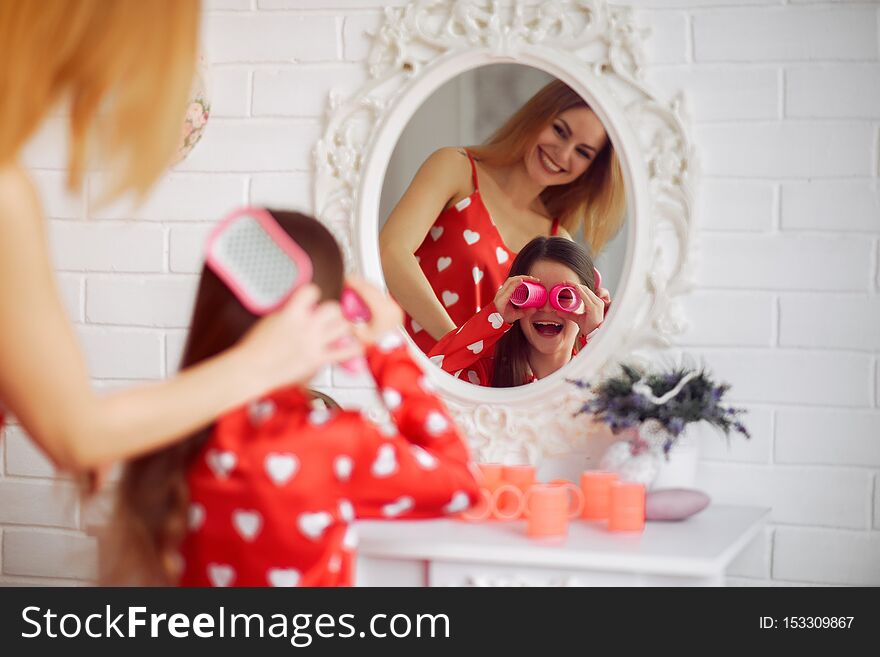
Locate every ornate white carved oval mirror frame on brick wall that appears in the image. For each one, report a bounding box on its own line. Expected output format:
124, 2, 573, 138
315, 0, 694, 462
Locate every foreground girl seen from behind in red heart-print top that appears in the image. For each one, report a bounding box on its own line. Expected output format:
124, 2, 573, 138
111, 212, 477, 586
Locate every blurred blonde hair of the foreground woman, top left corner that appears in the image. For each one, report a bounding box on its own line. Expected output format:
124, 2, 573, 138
0, 0, 200, 196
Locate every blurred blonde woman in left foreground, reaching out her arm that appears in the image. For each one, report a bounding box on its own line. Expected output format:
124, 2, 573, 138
0, 0, 356, 471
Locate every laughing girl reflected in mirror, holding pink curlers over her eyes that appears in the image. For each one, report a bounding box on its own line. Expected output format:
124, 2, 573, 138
429, 237, 605, 388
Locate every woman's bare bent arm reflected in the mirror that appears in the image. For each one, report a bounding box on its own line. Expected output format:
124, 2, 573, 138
379, 148, 472, 339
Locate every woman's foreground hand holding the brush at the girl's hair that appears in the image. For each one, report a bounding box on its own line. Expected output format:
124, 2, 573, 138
238, 284, 361, 390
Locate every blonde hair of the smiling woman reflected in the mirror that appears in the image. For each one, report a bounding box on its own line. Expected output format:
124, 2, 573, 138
470, 80, 626, 255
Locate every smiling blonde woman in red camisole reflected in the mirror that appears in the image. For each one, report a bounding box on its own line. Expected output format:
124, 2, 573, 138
379, 80, 625, 353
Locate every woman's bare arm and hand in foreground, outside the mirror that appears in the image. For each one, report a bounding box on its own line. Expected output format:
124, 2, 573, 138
0, 166, 358, 469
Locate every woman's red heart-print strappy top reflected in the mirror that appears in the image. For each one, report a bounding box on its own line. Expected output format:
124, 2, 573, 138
404, 153, 559, 353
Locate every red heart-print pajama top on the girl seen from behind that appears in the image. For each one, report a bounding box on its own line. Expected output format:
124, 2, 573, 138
180, 333, 477, 586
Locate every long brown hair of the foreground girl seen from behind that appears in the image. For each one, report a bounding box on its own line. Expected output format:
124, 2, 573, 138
102, 210, 344, 585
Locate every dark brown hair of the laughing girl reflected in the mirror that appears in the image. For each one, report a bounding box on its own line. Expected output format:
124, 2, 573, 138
492, 237, 596, 388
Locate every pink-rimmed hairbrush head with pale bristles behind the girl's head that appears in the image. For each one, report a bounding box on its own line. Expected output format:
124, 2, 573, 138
205, 207, 312, 315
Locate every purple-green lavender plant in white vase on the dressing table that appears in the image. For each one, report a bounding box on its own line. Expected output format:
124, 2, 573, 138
570, 364, 751, 456
